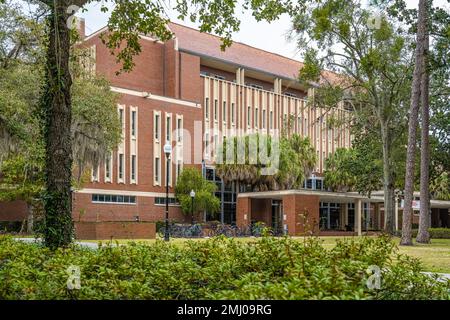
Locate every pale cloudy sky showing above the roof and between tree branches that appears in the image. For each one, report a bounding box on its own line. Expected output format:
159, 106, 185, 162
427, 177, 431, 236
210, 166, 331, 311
79, 0, 448, 60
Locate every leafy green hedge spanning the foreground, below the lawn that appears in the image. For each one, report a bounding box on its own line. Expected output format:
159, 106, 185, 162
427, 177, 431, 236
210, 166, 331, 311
0, 236, 450, 300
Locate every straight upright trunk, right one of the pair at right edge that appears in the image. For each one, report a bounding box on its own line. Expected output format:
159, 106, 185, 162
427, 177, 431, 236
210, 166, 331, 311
416, 34, 430, 243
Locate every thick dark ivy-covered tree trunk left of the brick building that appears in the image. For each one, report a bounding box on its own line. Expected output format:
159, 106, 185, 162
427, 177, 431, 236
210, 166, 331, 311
41, 1, 73, 249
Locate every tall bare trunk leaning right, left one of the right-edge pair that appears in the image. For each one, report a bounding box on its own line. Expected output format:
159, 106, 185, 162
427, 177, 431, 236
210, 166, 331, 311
400, 0, 428, 245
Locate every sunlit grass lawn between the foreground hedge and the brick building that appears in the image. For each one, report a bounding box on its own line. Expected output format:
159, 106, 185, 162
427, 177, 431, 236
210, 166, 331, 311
83, 237, 450, 274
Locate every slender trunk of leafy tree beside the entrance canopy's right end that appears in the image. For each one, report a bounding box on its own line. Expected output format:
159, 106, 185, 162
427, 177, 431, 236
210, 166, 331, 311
381, 123, 395, 235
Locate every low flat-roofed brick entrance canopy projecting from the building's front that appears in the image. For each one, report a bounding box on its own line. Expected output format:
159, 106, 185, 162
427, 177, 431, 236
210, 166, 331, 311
236, 190, 450, 235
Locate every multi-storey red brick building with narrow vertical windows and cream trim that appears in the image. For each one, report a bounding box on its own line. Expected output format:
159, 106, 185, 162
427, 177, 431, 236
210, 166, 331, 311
0, 23, 449, 235
